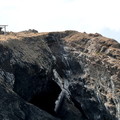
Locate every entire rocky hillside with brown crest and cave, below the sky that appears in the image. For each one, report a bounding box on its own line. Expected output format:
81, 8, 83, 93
0, 30, 120, 120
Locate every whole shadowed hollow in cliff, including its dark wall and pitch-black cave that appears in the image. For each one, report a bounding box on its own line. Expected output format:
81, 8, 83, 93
13, 65, 61, 116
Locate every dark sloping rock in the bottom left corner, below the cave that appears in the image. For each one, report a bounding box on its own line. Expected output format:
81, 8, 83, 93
0, 84, 56, 120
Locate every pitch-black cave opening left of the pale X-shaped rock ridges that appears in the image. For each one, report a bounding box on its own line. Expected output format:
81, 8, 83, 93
29, 80, 61, 116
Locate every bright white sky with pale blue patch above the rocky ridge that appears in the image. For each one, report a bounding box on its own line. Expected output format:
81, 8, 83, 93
0, 0, 120, 42
